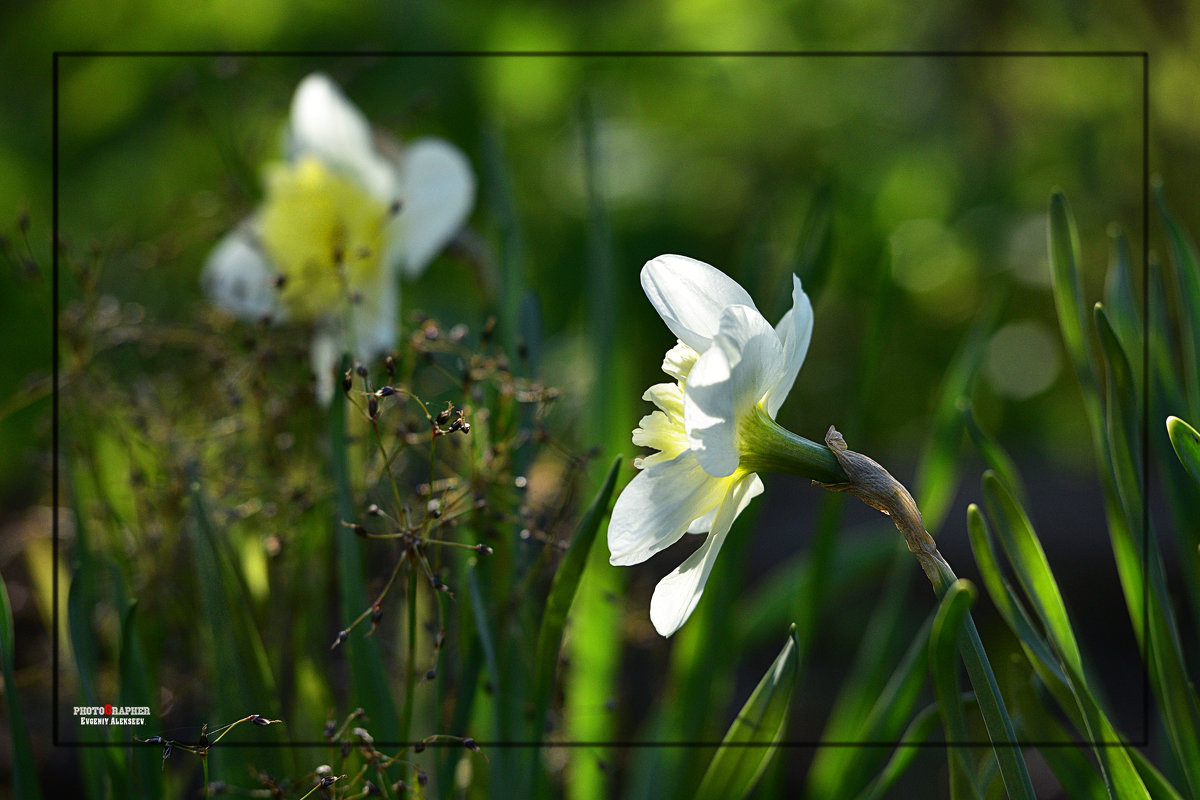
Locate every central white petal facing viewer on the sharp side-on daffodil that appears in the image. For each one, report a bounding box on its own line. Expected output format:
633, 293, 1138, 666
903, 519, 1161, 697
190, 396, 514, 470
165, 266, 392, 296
683, 306, 784, 477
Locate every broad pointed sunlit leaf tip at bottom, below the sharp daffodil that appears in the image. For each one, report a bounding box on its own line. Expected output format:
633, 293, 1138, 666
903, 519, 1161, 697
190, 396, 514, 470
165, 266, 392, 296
696, 625, 799, 800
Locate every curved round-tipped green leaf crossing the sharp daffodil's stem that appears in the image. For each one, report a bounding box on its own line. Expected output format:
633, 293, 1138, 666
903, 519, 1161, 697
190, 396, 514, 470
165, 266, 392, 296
929, 579, 979, 799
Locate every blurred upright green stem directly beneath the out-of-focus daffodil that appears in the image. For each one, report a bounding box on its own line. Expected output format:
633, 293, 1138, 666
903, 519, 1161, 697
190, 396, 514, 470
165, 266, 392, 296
328, 388, 403, 741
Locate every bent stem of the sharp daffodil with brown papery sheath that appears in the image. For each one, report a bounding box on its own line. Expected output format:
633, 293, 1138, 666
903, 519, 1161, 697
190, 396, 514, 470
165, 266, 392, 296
809, 426, 1034, 800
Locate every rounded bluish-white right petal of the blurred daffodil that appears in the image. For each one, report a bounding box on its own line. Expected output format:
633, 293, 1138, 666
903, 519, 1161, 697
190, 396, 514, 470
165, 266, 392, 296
386, 139, 475, 277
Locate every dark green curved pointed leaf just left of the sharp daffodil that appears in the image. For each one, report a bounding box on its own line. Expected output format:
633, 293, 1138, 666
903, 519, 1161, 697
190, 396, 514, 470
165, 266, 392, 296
534, 457, 622, 740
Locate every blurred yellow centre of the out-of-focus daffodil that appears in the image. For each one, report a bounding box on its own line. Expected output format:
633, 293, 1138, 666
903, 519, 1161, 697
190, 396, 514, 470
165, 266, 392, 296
258, 157, 389, 319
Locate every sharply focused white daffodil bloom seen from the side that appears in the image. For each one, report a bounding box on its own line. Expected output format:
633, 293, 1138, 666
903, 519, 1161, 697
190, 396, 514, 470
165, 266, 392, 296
608, 255, 812, 636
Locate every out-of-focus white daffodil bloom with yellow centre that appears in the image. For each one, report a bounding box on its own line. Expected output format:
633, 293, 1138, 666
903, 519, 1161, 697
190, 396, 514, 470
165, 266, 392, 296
202, 73, 475, 404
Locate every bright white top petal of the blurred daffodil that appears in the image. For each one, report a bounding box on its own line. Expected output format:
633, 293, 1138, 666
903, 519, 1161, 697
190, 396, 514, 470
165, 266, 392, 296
288, 72, 396, 205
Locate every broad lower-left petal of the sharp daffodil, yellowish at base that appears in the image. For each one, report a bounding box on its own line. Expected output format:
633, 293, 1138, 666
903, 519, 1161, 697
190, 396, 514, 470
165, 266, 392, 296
608, 452, 730, 566
